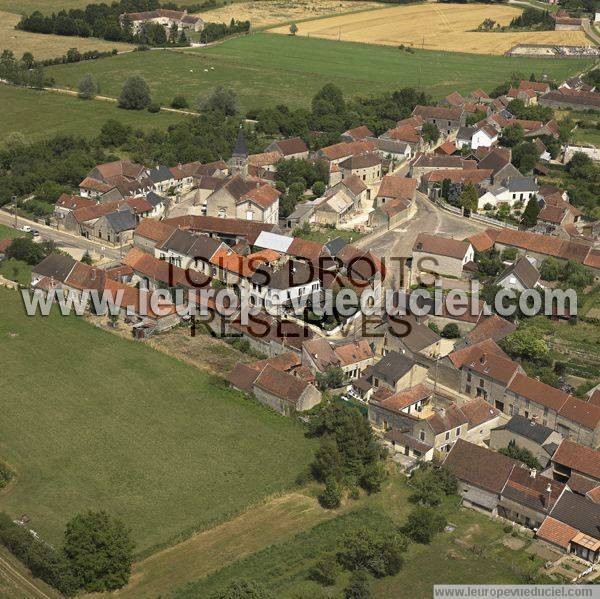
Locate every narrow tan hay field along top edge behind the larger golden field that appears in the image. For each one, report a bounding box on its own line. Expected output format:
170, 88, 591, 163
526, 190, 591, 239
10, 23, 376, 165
198, 0, 381, 32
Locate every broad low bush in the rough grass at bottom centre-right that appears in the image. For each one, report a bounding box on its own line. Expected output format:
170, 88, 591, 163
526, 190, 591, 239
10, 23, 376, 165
337, 528, 408, 578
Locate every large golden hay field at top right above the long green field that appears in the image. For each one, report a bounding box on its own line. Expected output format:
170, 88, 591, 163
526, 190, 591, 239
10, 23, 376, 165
272, 3, 591, 54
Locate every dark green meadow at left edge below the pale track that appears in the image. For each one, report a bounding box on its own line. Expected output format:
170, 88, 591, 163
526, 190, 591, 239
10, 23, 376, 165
0, 85, 186, 143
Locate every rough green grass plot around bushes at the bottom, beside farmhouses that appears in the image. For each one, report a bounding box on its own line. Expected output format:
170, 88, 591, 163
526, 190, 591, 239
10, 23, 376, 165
175, 475, 543, 599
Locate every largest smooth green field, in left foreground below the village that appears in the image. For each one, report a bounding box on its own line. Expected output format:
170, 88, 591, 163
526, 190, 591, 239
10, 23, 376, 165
0, 289, 314, 552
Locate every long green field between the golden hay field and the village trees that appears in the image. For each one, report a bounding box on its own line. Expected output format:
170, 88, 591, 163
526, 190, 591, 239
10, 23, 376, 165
43, 33, 591, 109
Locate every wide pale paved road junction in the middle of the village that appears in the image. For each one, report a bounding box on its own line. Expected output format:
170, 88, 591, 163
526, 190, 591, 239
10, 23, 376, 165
359, 193, 486, 260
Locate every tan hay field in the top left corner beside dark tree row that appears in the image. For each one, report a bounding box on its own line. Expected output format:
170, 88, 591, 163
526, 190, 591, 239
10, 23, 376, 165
0, 11, 132, 58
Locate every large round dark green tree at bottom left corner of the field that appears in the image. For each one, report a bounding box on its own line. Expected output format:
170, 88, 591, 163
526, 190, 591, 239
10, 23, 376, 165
63, 511, 134, 592
